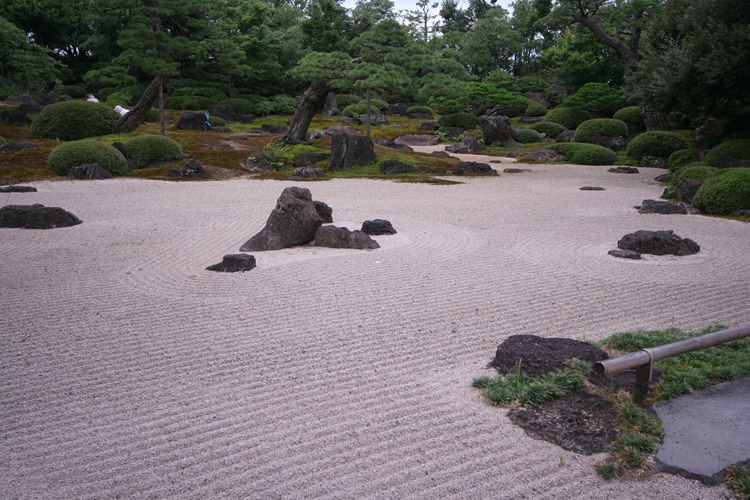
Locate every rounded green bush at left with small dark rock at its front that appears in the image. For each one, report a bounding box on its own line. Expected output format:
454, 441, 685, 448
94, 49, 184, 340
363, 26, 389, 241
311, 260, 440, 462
47, 140, 128, 175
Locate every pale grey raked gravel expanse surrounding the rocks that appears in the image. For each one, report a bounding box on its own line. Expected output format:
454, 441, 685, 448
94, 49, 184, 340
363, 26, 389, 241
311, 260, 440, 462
0, 165, 750, 499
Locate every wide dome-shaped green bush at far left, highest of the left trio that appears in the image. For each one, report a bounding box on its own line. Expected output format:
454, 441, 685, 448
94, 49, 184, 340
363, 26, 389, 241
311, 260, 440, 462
31, 101, 120, 141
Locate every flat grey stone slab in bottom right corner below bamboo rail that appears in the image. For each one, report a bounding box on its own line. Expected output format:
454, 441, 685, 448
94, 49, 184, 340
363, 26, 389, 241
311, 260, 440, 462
652, 377, 750, 485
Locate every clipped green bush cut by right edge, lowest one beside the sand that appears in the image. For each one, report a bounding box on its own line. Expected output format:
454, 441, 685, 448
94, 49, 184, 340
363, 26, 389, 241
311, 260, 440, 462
693, 168, 750, 215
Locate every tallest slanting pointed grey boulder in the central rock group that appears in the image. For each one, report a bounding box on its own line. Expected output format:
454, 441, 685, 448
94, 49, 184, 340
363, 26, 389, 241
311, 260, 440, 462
240, 187, 323, 252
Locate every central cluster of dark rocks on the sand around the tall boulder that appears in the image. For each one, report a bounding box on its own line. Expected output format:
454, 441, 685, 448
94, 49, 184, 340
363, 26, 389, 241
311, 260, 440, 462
207, 187, 396, 272
